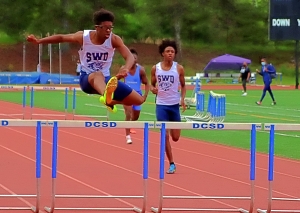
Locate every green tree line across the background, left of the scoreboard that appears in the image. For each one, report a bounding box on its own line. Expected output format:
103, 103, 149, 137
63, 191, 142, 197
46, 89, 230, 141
0, 0, 269, 44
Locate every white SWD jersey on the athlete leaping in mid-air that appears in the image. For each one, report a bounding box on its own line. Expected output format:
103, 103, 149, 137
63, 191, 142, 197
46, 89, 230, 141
78, 30, 115, 77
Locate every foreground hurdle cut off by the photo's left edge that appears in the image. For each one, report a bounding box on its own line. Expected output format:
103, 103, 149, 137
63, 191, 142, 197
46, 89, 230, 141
0, 120, 42, 213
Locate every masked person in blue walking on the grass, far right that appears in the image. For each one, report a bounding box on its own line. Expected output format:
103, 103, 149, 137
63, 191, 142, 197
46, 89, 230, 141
256, 58, 276, 105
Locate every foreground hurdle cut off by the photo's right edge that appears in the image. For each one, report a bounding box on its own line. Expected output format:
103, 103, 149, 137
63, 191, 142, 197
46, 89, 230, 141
257, 124, 300, 213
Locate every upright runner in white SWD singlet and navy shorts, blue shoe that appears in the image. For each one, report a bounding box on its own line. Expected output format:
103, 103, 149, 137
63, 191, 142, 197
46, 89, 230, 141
151, 40, 186, 174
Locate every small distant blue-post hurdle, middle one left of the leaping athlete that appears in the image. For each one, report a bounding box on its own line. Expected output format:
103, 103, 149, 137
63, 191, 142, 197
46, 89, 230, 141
29, 87, 67, 120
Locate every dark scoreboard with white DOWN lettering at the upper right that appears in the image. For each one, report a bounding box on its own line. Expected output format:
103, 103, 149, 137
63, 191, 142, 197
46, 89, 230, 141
269, 0, 300, 41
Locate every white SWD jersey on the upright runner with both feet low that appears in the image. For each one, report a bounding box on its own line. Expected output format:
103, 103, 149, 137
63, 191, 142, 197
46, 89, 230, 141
155, 62, 180, 105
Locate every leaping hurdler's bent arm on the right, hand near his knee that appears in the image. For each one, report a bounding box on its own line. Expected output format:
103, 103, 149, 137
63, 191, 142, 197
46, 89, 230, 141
112, 34, 134, 79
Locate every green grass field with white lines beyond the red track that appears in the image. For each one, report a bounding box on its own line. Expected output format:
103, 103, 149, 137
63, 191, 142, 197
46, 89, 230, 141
0, 90, 300, 159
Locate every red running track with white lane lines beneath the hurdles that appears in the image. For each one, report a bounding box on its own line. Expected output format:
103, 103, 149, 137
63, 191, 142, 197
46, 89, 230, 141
0, 102, 300, 212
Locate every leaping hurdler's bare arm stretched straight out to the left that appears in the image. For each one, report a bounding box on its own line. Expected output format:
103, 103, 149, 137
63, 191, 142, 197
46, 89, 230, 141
27, 31, 83, 46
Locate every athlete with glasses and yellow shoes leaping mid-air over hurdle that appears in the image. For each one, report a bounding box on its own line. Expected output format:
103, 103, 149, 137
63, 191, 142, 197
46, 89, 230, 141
27, 9, 144, 112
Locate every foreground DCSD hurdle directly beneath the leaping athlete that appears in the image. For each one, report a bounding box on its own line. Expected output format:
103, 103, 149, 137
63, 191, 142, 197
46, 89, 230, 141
44, 121, 154, 213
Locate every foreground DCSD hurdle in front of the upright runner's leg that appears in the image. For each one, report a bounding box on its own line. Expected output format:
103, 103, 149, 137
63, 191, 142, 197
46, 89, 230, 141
151, 122, 261, 213
